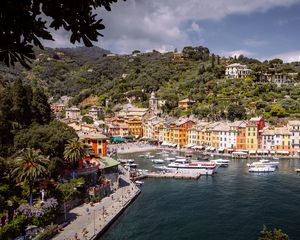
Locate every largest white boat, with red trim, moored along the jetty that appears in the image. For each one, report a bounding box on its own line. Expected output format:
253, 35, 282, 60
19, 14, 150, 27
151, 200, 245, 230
166, 159, 217, 175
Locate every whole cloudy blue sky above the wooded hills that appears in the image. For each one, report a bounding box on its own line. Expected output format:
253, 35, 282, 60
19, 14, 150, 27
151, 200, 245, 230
45, 0, 300, 62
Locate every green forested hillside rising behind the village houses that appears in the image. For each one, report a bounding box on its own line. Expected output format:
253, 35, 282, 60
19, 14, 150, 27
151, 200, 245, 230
0, 47, 300, 121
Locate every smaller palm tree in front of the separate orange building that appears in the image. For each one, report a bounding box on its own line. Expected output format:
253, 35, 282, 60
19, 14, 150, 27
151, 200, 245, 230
64, 138, 85, 179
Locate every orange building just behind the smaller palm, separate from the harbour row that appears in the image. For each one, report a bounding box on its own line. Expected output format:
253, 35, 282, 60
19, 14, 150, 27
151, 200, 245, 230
78, 132, 107, 157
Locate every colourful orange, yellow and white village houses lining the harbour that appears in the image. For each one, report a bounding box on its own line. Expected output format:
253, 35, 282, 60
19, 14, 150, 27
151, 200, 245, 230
51, 94, 300, 156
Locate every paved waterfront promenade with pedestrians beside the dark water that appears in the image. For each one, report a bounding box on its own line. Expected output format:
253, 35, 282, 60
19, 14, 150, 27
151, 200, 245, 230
53, 177, 140, 240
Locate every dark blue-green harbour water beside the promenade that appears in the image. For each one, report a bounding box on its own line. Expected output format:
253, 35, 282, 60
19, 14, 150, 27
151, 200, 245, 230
101, 151, 300, 240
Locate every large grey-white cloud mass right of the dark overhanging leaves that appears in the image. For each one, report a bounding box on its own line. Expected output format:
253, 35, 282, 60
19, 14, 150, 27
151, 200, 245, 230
44, 0, 299, 53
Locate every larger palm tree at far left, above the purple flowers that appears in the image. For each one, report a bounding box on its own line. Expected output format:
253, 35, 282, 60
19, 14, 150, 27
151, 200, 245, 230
12, 148, 50, 206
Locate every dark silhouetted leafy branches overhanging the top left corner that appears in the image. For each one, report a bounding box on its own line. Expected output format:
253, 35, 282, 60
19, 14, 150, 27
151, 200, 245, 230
0, 0, 123, 68
